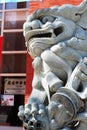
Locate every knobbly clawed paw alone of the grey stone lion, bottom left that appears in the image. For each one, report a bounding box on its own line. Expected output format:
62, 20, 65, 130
18, 103, 49, 130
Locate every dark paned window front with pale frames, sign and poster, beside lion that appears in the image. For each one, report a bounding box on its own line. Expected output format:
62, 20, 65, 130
0, 2, 29, 126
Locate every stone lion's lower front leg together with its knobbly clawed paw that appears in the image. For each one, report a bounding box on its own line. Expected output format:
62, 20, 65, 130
18, 89, 49, 130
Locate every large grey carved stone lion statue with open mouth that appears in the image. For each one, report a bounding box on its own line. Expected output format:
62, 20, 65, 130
18, 0, 87, 130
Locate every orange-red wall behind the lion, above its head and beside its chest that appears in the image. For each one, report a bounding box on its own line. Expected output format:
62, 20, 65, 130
25, 0, 82, 102
